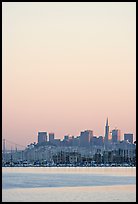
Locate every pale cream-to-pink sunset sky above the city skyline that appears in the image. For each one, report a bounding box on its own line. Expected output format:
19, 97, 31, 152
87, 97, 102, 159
2, 2, 136, 146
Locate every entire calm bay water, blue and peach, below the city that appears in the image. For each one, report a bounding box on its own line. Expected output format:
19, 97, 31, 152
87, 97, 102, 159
2, 167, 136, 202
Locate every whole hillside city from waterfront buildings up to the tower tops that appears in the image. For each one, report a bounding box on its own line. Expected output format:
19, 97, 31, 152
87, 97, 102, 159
3, 118, 136, 166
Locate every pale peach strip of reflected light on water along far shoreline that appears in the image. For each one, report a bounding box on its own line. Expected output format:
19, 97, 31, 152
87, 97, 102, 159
2, 167, 136, 176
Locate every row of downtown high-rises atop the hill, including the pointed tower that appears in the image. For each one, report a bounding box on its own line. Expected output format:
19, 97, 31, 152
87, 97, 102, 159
37, 118, 133, 148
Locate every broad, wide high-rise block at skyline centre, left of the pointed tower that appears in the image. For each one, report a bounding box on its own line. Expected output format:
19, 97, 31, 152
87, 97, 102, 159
80, 130, 93, 147
